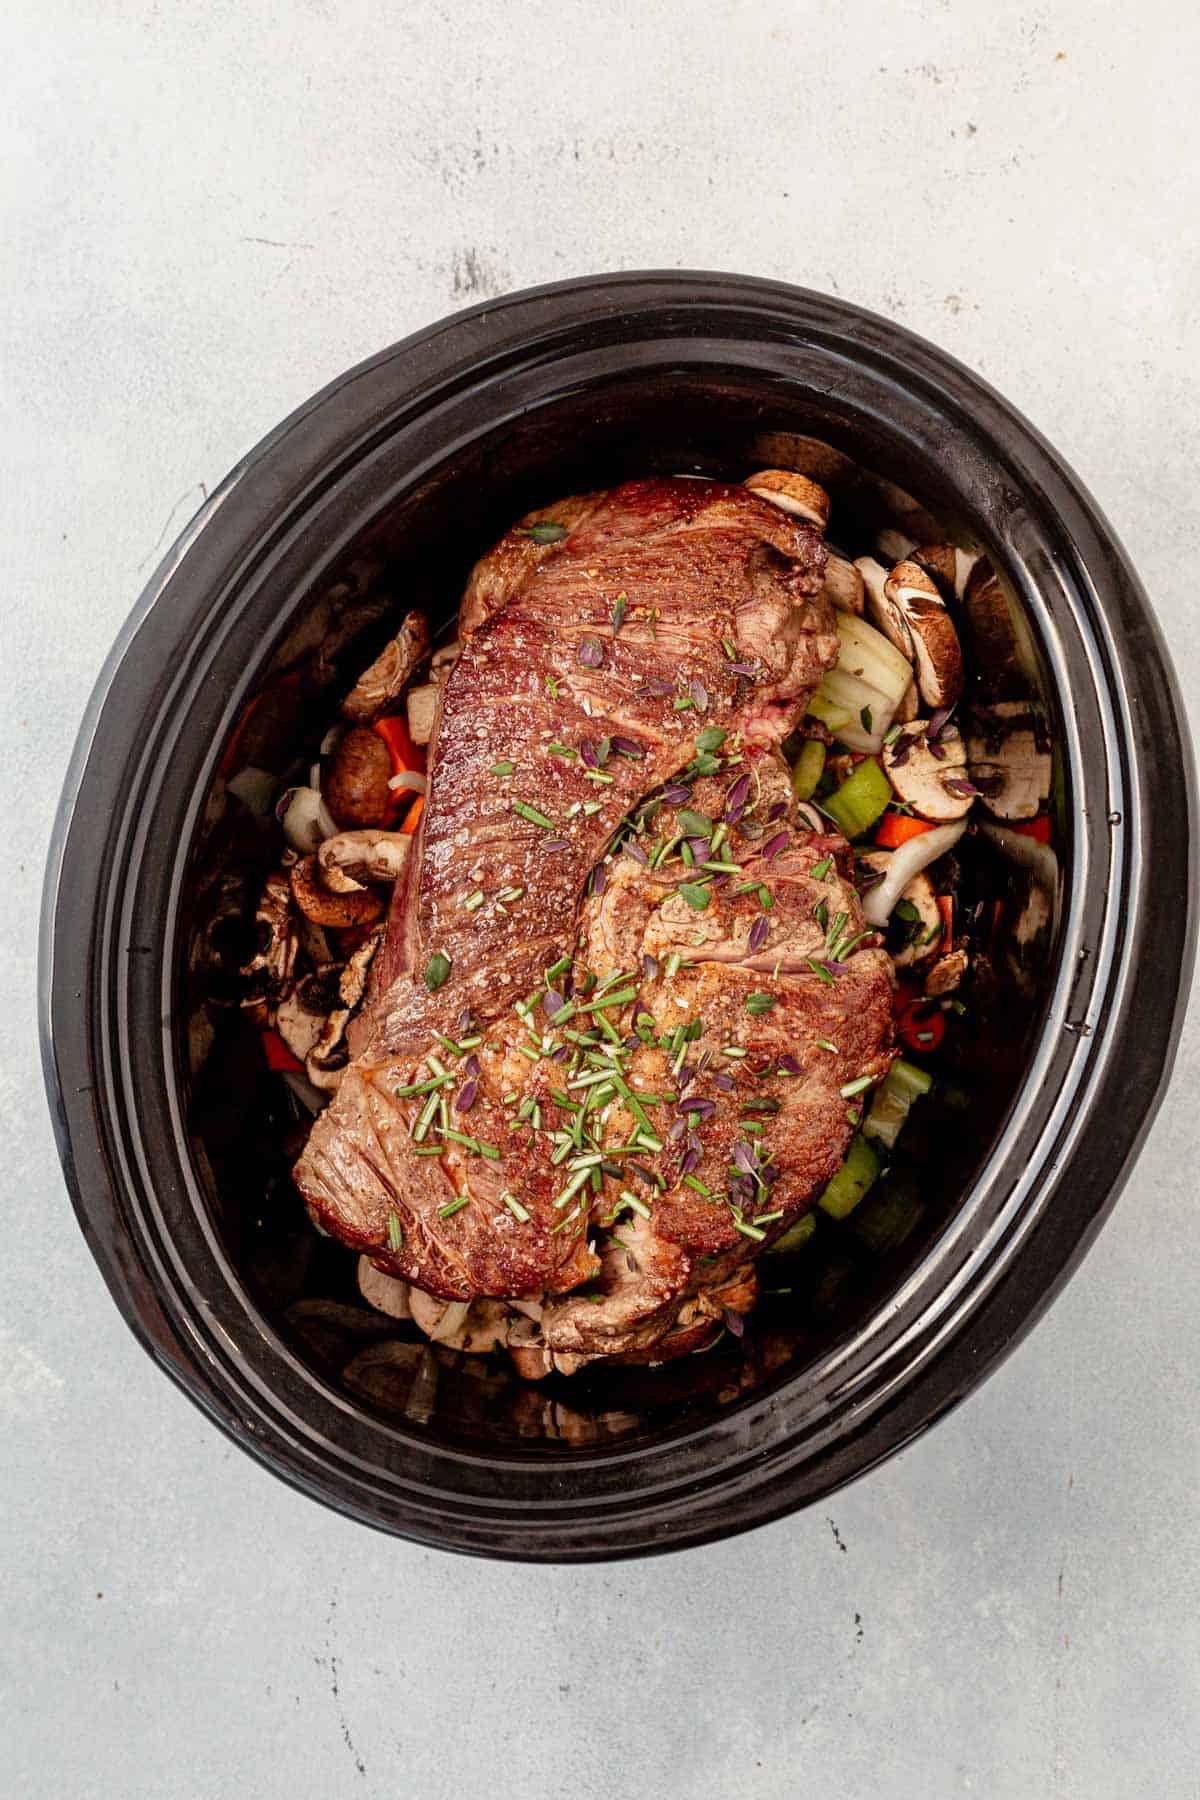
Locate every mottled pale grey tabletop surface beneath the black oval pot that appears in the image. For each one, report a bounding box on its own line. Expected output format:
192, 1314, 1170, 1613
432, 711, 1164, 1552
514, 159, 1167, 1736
0, 0, 1200, 1800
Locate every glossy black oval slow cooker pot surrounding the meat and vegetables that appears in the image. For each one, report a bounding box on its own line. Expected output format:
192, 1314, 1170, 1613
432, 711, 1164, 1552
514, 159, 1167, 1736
43, 275, 1195, 1557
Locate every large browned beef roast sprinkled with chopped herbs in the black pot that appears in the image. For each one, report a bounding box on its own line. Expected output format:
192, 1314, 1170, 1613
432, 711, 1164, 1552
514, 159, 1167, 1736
295, 481, 891, 1357
